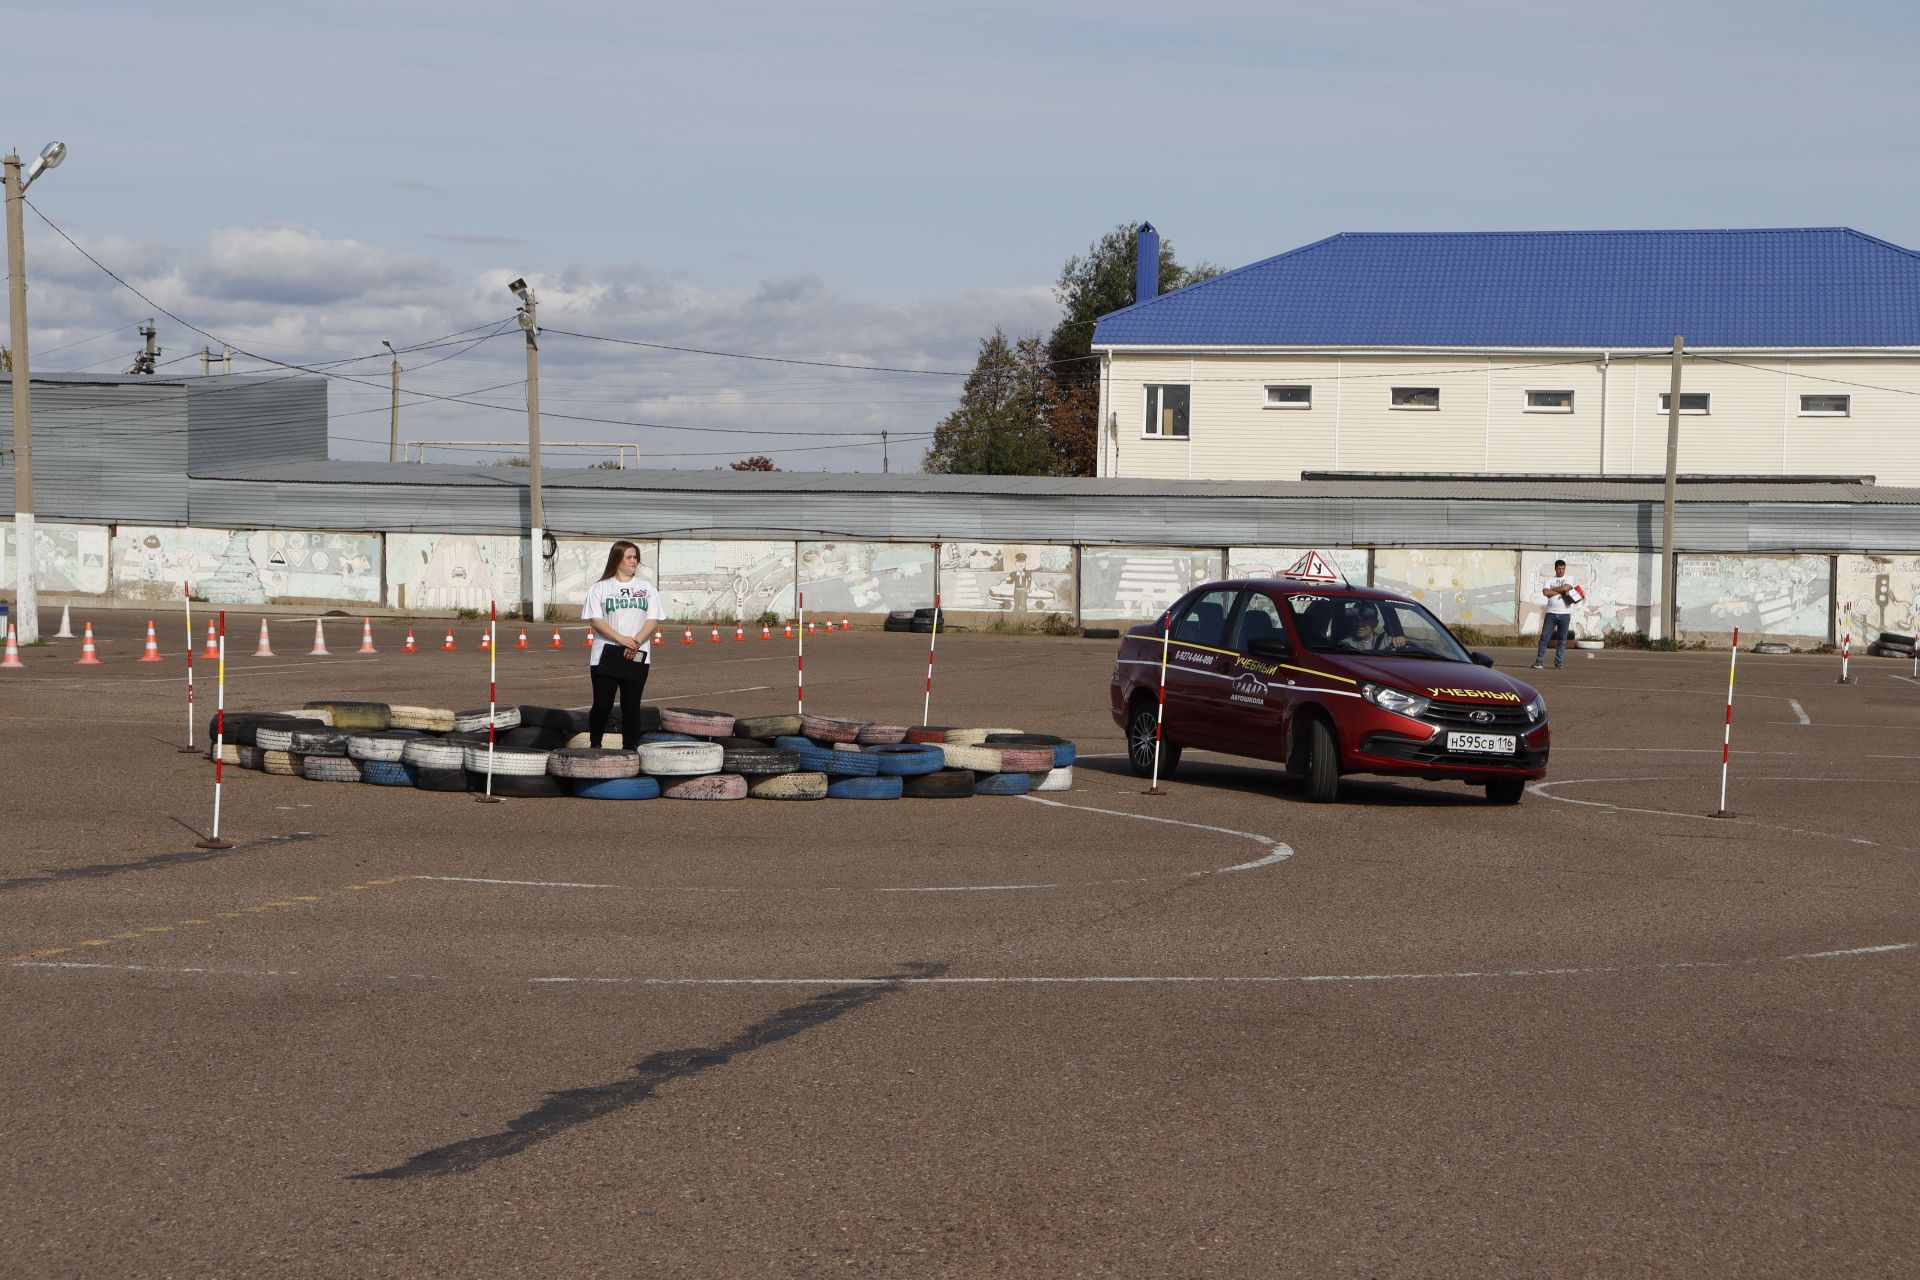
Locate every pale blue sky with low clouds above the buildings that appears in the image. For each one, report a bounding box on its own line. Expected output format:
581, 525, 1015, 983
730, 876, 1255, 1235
15, 0, 1920, 470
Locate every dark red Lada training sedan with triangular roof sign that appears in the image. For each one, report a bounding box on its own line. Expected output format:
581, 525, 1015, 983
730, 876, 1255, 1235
1112, 578, 1549, 804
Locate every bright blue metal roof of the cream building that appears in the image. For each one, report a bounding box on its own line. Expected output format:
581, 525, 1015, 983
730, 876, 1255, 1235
1092, 226, 1920, 349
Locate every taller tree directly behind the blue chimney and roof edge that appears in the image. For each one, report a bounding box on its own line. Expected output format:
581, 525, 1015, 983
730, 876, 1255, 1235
1046, 223, 1219, 476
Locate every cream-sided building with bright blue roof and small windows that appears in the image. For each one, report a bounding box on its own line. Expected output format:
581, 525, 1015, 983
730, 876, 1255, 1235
1094, 226, 1920, 486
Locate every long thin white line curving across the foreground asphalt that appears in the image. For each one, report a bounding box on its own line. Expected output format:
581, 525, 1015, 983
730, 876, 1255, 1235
6, 942, 1920, 986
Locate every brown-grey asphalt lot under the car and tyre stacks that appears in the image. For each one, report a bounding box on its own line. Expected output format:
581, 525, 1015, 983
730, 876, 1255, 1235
0, 614, 1920, 1276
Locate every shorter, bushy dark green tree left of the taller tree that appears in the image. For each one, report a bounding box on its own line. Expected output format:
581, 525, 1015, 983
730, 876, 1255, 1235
922, 328, 1054, 476
